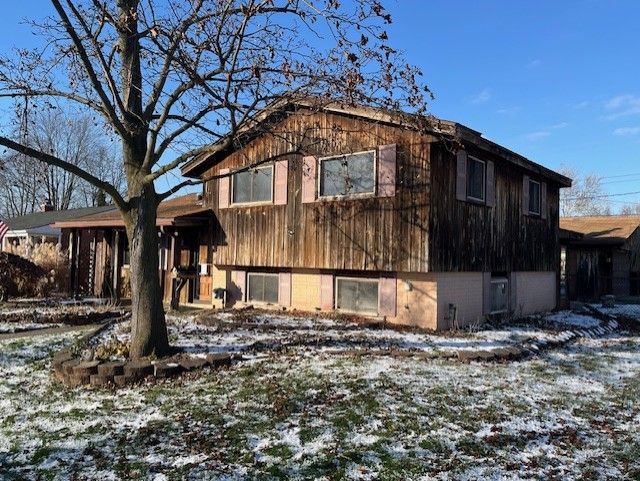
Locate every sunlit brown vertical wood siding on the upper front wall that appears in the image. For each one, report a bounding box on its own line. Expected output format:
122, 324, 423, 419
204, 113, 432, 272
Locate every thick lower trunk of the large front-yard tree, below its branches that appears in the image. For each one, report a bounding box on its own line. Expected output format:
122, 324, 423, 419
126, 184, 169, 359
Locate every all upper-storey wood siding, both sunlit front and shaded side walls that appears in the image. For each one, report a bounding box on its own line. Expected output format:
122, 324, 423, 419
203, 109, 559, 272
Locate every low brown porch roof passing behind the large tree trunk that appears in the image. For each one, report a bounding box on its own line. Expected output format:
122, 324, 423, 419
54, 194, 211, 229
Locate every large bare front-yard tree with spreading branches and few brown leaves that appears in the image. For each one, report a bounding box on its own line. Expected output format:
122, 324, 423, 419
0, 0, 428, 358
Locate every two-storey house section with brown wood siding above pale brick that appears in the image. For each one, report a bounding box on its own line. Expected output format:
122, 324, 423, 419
176, 102, 571, 329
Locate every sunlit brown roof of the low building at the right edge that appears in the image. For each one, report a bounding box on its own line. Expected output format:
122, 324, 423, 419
560, 215, 640, 244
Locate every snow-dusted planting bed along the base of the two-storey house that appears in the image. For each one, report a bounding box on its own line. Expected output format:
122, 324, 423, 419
94, 311, 600, 362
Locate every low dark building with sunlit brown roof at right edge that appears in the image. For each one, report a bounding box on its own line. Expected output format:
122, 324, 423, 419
560, 215, 640, 301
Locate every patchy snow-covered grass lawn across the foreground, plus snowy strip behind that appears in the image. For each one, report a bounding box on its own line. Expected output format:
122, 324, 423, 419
0, 310, 640, 480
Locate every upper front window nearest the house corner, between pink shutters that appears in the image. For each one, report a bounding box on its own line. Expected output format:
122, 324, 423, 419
319, 150, 376, 197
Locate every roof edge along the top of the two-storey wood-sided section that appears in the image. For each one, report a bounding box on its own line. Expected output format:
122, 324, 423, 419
181, 98, 571, 187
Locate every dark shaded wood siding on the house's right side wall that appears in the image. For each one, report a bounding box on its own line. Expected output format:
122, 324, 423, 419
429, 143, 559, 272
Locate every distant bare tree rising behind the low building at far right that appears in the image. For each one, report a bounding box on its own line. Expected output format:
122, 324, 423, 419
560, 167, 611, 217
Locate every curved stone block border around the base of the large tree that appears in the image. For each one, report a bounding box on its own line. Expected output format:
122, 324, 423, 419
51, 315, 232, 387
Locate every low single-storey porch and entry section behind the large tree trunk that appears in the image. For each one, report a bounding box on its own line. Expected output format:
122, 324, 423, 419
54, 194, 214, 306
